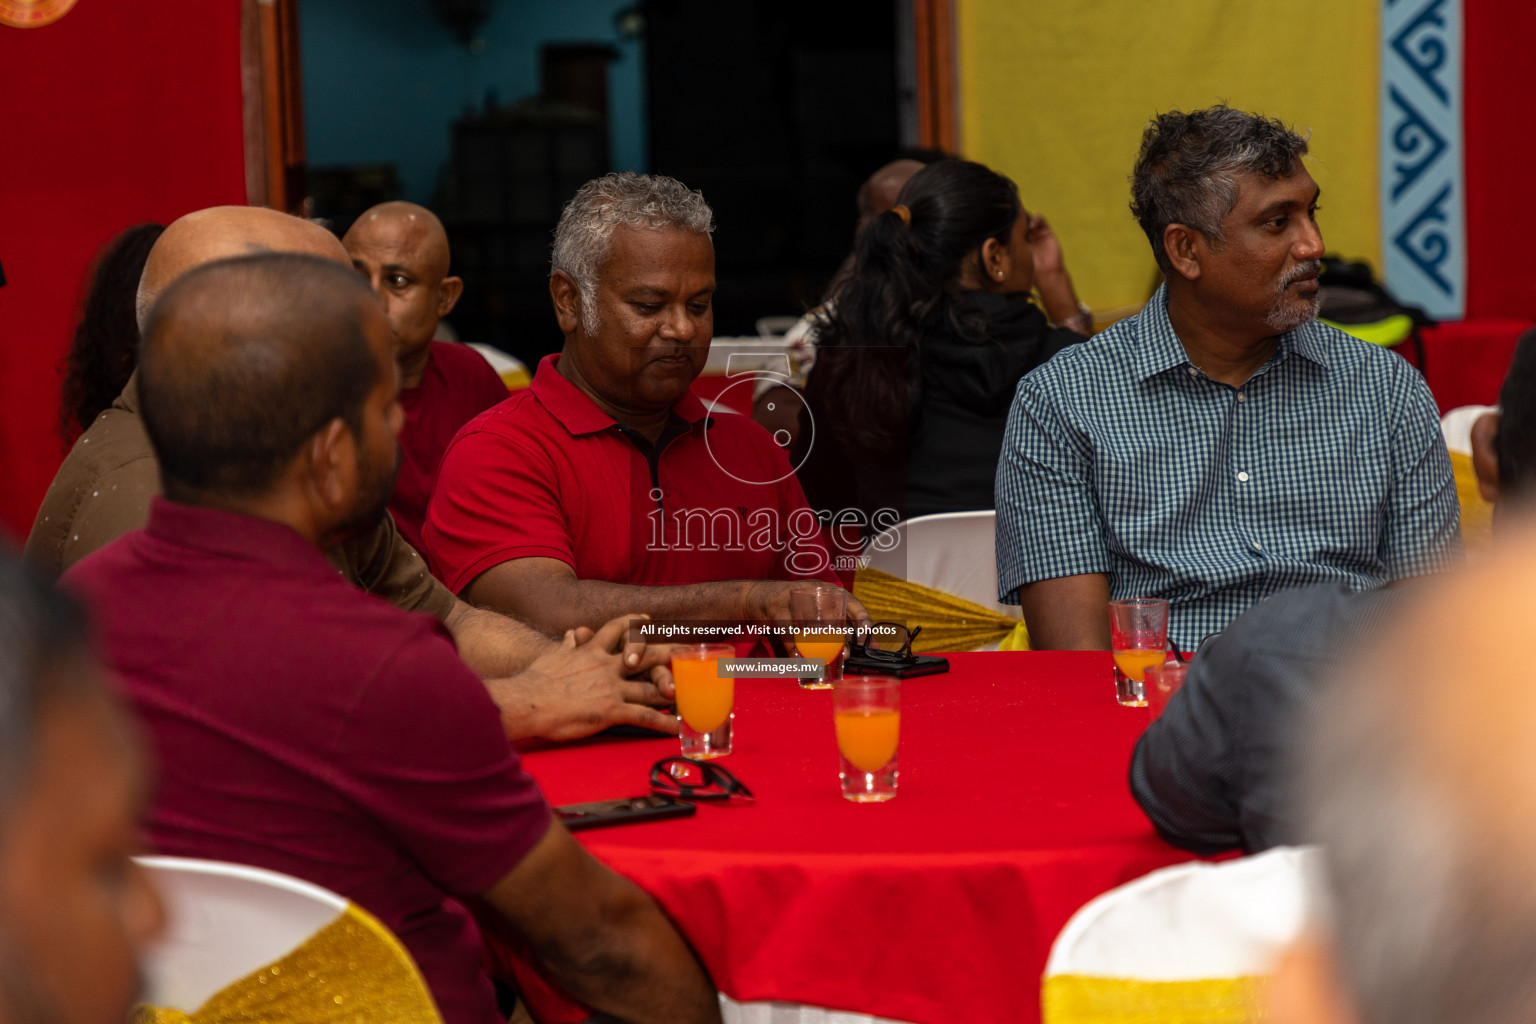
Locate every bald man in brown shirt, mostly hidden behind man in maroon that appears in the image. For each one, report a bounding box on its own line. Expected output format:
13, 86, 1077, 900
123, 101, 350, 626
25, 206, 677, 738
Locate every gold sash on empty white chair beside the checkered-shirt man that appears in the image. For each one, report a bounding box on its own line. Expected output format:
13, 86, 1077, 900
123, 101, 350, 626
854, 567, 1029, 654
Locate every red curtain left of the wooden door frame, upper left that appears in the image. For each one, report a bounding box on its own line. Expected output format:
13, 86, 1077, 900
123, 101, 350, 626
0, 0, 246, 542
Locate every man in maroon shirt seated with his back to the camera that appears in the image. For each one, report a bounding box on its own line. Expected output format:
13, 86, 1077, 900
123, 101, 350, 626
65, 253, 719, 1024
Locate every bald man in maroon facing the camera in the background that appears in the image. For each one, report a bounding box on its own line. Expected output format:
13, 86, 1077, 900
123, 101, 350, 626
341, 203, 507, 548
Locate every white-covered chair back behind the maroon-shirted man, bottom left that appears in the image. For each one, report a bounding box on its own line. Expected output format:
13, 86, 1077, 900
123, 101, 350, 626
137, 857, 439, 1024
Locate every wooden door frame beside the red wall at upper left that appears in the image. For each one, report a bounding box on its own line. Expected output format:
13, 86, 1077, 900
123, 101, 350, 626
240, 0, 309, 215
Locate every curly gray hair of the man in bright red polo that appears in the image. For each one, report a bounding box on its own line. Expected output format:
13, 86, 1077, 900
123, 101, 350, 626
550, 170, 714, 335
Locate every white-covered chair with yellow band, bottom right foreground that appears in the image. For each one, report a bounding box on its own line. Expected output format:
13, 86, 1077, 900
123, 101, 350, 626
1041, 846, 1316, 1024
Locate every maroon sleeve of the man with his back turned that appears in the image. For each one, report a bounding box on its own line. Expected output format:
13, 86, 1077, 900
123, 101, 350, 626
335, 623, 550, 897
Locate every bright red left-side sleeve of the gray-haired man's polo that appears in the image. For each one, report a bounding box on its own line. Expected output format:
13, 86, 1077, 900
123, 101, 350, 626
421, 417, 576, 594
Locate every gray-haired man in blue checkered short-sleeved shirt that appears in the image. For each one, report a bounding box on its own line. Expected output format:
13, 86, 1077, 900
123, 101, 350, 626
995, 106, 1461, 649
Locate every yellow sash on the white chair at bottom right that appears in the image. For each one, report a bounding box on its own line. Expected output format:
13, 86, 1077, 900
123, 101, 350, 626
1040, 975, 1266, 1024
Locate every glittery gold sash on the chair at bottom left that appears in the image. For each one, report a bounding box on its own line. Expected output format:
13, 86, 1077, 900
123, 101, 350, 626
132, 904, 442, 1024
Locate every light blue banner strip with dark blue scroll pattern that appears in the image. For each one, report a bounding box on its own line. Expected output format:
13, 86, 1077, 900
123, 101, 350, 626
1379, 0, 1467, 319
